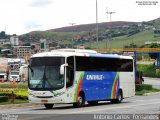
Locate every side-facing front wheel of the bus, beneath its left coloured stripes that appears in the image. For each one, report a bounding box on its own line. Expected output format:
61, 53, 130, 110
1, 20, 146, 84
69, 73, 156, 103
73, 93, 85, 108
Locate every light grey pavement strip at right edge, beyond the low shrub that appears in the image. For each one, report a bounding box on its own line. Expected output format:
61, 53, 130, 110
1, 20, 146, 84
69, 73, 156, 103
143, 77, 160, 89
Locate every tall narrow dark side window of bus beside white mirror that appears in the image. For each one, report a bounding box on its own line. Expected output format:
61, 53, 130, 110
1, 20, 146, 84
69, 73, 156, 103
66, 57, 74, 87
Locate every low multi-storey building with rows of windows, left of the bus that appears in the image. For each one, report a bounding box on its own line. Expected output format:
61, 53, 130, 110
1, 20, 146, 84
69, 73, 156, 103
14, 46, 31, 58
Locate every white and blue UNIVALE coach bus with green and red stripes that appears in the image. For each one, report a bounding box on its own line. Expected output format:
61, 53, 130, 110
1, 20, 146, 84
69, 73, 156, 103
28, 49, 135, 109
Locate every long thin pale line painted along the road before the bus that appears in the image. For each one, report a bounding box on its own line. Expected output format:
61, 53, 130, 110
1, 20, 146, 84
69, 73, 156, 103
70, 101, 160, 114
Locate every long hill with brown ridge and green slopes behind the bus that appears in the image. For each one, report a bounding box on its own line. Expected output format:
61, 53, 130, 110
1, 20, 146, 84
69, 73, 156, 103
19, 18, 160, 48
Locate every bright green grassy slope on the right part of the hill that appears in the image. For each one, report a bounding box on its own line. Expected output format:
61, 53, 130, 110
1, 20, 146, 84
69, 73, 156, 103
84, 30, 160, 48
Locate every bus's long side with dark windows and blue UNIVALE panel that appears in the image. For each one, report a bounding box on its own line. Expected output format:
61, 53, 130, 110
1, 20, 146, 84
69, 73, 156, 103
72, 55, 135, 104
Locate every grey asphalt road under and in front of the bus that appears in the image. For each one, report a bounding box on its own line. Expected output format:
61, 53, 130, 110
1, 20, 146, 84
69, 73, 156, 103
0, 93, 160, 120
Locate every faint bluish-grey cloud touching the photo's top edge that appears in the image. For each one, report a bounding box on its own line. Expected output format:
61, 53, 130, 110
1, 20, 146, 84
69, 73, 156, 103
29, 0, 53, 7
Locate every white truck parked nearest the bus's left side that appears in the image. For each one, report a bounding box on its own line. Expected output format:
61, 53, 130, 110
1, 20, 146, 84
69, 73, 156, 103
9, 71, 20, 82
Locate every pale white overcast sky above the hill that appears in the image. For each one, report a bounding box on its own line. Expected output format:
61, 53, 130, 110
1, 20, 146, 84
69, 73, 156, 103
0, 0, 160, 35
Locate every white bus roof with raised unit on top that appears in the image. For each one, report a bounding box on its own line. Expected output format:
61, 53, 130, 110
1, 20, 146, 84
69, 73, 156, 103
32, 49, 133, 59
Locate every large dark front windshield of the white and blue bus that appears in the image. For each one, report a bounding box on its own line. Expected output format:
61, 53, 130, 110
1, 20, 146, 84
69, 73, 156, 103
28, 57, 65, 90
